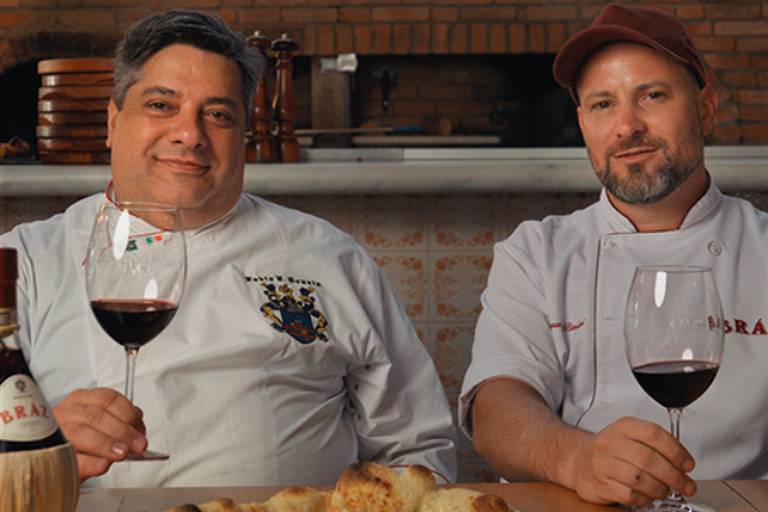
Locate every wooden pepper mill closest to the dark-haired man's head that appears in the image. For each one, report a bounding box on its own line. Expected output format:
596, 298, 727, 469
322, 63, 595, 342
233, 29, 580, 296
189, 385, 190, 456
245, 30, 277, 162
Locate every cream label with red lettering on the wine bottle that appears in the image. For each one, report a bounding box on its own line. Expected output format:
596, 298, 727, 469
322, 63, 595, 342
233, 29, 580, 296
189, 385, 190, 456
0, 373, 58, 442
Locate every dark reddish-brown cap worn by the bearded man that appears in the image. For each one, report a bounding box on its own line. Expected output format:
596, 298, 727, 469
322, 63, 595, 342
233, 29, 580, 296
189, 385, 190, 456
553, 4, 706, 102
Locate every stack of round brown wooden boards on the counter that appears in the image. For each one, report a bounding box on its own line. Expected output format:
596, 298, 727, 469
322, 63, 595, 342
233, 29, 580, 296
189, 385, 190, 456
37, 58, 114, 164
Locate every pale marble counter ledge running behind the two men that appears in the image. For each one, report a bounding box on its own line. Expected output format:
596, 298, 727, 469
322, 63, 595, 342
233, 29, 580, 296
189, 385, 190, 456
0, 146, 768, 197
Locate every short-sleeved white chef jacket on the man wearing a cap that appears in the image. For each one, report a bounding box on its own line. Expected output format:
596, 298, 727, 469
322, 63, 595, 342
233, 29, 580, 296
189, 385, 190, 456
459, 184, 768, 479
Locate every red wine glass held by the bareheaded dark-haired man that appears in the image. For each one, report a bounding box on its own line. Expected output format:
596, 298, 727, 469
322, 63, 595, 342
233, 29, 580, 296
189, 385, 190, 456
85, 200, 187, 460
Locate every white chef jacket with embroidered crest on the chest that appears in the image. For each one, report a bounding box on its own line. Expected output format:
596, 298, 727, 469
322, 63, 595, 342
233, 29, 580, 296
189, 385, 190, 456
0, 194, 456, 487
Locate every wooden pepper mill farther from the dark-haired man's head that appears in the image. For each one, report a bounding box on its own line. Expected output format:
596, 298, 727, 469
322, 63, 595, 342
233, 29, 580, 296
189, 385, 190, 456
272, 34, 299, 162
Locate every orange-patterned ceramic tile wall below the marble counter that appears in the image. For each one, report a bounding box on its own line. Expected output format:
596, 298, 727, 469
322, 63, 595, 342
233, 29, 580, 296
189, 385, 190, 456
0, 193, 768, 482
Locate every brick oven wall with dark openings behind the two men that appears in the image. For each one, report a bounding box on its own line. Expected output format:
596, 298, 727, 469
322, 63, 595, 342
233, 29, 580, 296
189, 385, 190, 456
0, 0, 768, 151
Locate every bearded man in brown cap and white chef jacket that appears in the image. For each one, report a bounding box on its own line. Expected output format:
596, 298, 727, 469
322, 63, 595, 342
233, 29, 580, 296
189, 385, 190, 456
459, 4, 768, 506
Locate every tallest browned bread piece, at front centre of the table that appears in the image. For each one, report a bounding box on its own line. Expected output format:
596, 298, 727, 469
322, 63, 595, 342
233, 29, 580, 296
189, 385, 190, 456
331, 462, 437, 512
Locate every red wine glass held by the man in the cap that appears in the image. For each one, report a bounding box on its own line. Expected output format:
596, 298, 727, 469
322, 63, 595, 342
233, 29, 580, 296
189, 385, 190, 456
624, 266, 723, 512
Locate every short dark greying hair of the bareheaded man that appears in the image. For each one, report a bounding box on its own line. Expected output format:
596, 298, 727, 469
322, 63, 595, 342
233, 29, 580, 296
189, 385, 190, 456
112, 9, 263, 126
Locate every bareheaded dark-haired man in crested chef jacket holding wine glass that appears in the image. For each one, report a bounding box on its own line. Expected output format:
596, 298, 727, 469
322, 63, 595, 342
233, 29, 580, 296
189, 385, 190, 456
0, 10, 456, 487
